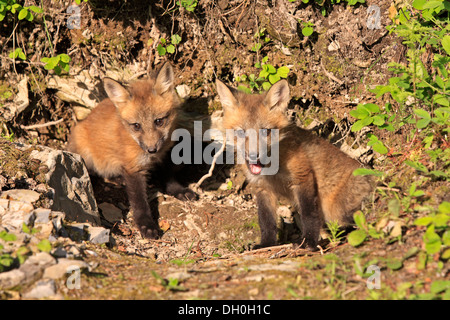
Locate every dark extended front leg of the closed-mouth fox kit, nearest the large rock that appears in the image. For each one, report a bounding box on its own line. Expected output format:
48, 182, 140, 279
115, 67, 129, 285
123, 172, 159, 239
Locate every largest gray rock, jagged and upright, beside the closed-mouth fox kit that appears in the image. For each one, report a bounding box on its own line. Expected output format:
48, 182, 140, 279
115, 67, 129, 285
30, 147, 100, 225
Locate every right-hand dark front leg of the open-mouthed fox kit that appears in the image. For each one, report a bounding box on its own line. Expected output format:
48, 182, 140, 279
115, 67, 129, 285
292, 178, 323, 250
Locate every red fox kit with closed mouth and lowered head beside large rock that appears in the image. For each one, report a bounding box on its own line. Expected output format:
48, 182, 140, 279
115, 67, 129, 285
68, 63, 192, 238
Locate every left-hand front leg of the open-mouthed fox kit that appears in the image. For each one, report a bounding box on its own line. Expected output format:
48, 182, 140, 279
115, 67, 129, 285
254, 190, 277, 249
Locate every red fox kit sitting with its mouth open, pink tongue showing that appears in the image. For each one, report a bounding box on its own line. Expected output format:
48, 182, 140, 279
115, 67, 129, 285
216, 80, 372, 249
